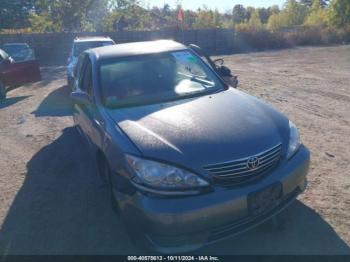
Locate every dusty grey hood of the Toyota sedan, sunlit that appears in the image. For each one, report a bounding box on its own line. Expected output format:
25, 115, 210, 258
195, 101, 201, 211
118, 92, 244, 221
107, 88, 289, 173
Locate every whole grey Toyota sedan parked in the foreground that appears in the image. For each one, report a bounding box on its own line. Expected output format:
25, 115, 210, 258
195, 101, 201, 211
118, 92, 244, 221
71, 41, 310, 253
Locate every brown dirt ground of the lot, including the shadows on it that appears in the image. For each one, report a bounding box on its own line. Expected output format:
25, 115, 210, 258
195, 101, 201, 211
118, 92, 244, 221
0, 46, 350, 254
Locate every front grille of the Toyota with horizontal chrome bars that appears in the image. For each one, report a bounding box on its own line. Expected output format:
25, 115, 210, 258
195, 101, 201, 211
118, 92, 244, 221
203, 144, 282, 184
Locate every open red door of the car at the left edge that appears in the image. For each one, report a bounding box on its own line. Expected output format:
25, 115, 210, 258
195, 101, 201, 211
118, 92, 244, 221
2, 60, 41, 86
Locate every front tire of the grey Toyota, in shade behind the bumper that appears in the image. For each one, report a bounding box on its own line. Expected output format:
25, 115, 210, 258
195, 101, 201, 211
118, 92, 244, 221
97, 153, 119, 213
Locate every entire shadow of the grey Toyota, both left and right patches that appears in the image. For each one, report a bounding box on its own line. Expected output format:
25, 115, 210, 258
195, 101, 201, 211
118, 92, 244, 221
0, 127, 350, 255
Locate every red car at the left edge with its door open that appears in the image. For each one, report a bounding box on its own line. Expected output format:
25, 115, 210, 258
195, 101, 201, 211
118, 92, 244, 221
0, 49, 41, 100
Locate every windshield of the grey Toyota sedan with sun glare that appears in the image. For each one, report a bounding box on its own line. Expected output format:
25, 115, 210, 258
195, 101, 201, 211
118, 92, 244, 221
100, 50, 224, 107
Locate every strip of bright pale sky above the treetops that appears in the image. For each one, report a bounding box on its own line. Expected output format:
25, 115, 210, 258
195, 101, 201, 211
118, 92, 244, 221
141, 0, 285, 11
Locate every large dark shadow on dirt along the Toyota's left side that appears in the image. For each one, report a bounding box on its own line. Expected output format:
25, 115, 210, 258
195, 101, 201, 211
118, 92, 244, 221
0, 127, 134, 255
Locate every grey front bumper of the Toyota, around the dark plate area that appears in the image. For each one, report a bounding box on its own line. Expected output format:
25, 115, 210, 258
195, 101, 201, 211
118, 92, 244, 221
114, 146, 310, 253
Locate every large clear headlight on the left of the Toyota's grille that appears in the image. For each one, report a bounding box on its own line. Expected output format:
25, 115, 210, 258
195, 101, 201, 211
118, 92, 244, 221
126, 155, 209, 193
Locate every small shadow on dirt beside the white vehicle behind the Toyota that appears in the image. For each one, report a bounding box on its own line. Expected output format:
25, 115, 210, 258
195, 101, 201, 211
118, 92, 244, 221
32, 85, 73, 117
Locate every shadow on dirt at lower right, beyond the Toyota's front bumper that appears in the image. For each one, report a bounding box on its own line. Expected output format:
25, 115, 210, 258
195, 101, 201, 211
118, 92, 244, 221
199, 200, 350, 255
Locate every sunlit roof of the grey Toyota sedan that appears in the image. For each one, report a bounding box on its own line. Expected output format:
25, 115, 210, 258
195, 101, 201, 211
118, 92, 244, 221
86, 40, 188, 60
